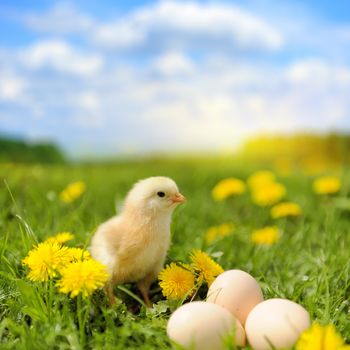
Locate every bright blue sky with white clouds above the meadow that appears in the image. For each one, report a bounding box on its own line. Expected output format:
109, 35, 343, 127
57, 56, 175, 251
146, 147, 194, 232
0, 0, 350, 157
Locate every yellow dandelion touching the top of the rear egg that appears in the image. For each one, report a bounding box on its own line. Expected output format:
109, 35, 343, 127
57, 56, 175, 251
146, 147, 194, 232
190, 249, 224, 286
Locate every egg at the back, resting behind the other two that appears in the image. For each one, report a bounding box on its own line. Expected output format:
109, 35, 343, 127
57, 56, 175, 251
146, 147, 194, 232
207, 270, 264, 326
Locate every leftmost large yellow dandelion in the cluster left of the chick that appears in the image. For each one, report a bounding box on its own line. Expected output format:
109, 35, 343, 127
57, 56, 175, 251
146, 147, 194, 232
22, 242, 70, 281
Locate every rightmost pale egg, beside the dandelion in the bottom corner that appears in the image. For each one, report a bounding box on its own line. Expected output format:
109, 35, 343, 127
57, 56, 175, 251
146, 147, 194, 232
245, 299, 310, 350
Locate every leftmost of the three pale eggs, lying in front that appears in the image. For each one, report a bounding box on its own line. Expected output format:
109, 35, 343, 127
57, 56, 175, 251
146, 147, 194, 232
167, 301, 245, 350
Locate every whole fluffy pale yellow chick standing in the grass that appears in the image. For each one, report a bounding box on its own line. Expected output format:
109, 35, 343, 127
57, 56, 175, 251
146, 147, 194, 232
90, 176, 185, 307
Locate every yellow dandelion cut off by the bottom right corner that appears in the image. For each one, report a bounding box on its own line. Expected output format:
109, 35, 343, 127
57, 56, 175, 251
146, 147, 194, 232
296, 323, 350, 350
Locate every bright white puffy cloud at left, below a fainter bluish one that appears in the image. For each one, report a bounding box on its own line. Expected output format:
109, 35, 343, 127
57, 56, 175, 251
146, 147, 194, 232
19, 40, 104, 75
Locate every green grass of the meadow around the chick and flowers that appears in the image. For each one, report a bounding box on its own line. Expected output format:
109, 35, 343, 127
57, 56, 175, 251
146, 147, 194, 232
0, 160, 350, 349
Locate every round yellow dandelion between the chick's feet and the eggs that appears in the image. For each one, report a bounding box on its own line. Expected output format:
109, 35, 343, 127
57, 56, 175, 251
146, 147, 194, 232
158, 263, 195, 300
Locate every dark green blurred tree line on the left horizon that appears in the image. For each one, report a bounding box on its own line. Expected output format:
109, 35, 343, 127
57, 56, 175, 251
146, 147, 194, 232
0, 137, 65, 163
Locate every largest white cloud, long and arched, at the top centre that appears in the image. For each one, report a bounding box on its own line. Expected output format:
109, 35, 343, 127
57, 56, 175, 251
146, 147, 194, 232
94, 1, 283, 50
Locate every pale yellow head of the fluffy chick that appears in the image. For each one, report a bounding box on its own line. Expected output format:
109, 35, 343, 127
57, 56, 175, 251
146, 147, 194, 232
125, 176, 186, 213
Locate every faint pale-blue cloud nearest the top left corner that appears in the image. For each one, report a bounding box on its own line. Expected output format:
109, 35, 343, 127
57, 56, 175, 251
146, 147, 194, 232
23, 3, 94, 34
